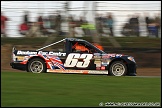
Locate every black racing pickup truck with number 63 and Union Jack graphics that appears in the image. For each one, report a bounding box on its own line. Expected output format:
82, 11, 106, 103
10, 38, 137, 76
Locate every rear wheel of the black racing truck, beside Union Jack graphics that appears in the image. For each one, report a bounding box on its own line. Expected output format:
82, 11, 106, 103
27, 58, 46, 73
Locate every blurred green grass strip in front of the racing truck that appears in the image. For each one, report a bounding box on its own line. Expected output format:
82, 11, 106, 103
1, 72, 161, 107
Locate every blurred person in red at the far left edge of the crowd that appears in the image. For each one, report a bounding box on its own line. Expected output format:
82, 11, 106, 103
1, 12, 9, 37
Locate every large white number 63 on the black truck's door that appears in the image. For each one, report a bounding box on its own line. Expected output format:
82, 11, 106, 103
64, 53, 93, 68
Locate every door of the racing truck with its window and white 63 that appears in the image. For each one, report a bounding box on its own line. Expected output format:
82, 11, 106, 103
64, 41, 96, 70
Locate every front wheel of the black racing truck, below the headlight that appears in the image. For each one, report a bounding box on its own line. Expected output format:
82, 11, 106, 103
109, 61, 127, 76
